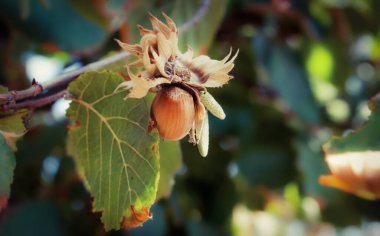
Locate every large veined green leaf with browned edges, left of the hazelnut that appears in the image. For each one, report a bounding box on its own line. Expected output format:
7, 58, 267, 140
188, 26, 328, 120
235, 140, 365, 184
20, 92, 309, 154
67, 72, 159, 230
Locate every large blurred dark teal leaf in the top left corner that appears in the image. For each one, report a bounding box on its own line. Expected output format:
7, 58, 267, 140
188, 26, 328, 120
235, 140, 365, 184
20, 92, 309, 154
0, 0, 109, 50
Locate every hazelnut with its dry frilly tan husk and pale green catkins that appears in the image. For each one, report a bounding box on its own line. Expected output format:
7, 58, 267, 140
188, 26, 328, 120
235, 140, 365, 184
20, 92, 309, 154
117, 14, 238, 156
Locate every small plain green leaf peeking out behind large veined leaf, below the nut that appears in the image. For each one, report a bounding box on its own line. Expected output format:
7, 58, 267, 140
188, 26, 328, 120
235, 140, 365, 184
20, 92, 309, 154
157, 140, 182, 200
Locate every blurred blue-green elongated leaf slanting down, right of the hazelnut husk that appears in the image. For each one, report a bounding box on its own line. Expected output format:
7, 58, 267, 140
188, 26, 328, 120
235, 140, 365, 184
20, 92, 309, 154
253, 37, 321, 125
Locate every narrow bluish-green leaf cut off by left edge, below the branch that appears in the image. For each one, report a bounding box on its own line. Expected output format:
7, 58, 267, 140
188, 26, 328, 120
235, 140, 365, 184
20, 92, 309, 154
0, 135, 16, 211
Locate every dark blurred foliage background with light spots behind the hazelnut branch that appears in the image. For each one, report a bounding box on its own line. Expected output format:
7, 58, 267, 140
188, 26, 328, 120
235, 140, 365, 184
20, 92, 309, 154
0, 0, 380, 236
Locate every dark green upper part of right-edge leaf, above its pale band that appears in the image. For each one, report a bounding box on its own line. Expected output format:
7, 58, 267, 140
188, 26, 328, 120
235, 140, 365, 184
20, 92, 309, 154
324, 102, 380, 154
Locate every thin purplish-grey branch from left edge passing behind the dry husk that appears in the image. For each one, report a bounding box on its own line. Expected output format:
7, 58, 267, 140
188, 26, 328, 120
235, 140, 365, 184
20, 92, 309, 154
0, 0, 210, 111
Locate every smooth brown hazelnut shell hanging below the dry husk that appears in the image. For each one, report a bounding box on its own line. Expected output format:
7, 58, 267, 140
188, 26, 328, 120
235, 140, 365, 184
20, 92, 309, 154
151, 85, 196, 140
